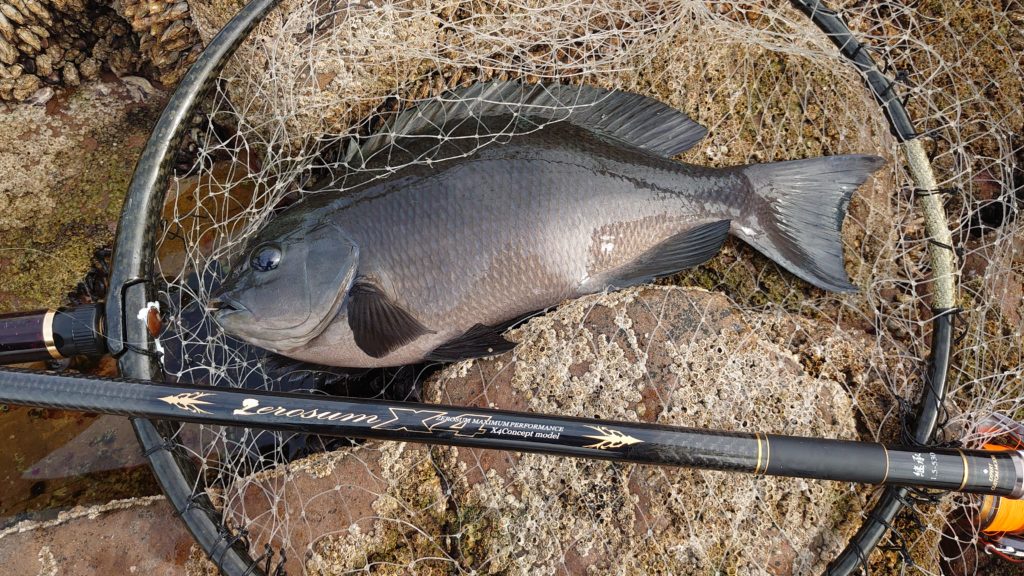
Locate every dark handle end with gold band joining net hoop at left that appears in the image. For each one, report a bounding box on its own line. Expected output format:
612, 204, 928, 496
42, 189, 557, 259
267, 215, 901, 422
0, 304, 106, 364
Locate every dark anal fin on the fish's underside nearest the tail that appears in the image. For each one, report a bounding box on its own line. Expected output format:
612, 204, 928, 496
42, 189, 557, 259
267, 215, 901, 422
582, 220, 730, 292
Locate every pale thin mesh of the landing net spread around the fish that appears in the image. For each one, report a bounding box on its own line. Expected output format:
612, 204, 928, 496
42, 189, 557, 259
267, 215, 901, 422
146, 0, 1024, 574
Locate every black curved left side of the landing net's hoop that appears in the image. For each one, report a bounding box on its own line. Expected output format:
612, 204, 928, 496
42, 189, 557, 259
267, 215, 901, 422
105, 0, 278, 576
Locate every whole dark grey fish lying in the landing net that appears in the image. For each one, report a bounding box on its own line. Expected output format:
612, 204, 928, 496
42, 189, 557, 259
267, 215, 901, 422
211, 81, 885, 368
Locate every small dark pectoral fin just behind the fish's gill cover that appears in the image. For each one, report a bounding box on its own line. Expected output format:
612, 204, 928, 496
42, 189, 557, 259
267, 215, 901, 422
348, 279, 434, 358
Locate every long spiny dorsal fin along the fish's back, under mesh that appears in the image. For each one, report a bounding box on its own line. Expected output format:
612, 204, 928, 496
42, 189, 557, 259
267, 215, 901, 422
346, 81, 708, 166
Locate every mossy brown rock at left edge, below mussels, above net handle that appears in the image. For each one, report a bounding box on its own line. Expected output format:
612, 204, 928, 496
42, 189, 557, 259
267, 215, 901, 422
0, 78, 166, 312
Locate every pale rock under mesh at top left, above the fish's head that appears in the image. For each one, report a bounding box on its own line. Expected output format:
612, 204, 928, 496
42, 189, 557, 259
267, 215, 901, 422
190, 0, 440, 145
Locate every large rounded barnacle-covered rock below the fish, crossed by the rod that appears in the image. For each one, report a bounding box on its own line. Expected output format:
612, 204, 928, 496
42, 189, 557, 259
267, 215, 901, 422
417, 287, 867, 574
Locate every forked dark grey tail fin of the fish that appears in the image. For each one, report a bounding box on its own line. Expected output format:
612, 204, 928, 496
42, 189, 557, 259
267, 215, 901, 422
732, 155, 885, 292
